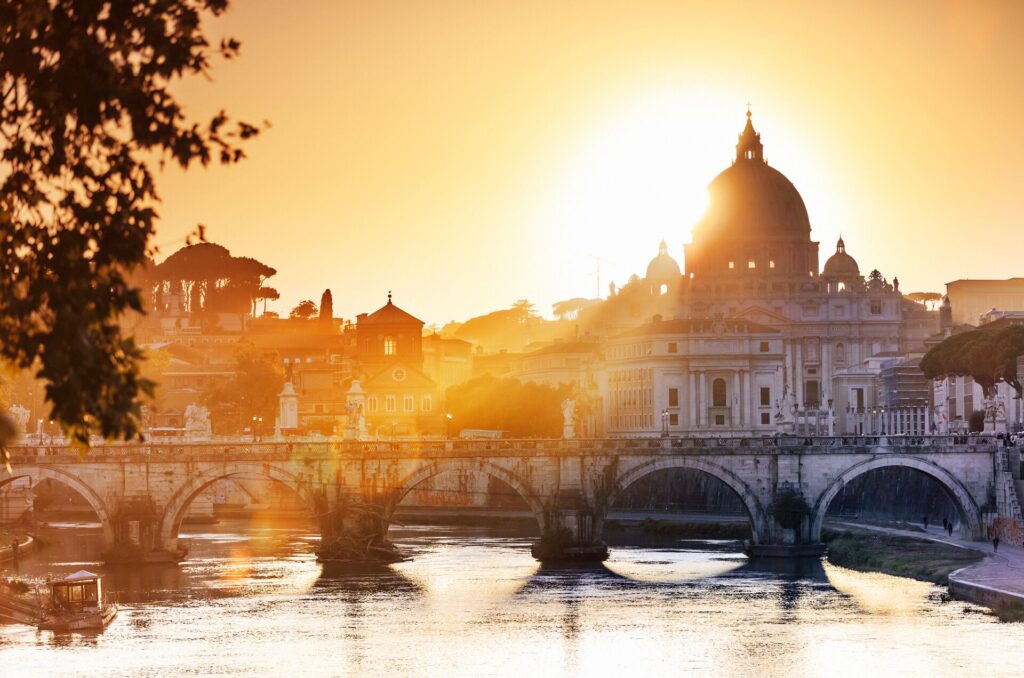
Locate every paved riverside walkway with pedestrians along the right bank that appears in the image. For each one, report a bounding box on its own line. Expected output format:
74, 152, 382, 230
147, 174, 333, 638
835, 521, 1024, 598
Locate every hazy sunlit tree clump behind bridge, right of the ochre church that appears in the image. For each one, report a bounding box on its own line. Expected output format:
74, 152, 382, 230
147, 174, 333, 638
445, 375, 572, 438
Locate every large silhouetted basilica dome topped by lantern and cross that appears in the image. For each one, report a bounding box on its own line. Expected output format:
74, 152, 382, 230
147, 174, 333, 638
693, 112, 811, 243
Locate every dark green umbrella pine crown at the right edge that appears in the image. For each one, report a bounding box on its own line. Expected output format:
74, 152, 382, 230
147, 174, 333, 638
921, 326, 1024, 397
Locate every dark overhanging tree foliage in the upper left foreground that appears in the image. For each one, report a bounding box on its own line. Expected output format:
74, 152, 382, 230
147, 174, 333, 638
0, 0, 258, 447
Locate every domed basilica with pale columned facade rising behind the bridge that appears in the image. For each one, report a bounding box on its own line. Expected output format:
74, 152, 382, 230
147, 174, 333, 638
581, 113, 937, 436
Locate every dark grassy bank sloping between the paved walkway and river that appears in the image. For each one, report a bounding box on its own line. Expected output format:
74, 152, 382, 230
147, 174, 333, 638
822, 531, 985, 585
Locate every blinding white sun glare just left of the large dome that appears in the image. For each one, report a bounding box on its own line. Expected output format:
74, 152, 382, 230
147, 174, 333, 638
542, 91, 835, 303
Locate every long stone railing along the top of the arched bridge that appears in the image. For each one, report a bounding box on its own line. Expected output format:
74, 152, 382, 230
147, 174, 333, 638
10, 435, 1000, 463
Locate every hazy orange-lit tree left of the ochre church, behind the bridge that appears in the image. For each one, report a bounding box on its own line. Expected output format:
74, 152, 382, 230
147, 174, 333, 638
203, 344, 285, 433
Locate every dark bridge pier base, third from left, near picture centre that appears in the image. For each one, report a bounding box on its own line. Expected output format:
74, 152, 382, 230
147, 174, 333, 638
530, 491, 608, 562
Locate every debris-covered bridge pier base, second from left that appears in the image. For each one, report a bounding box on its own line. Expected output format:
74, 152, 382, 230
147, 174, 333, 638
316, 494, 404, 563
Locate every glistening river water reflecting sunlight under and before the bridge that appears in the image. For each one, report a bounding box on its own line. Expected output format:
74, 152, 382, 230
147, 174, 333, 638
0, 521, 1024, 678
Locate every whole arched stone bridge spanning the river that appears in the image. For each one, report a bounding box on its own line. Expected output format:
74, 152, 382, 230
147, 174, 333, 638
0, 436, 1007, 561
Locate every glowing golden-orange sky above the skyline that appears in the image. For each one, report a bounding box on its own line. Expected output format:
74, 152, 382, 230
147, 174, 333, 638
157, 0, 1024, 324
